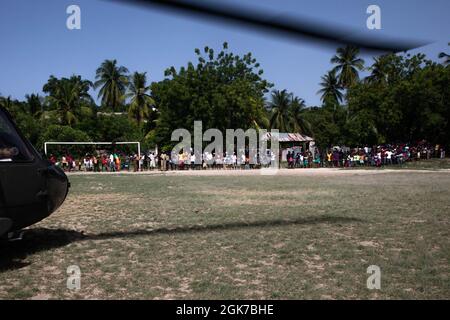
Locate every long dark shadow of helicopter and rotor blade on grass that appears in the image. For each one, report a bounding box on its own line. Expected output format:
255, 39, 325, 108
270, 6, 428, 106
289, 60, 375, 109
0, 215, 362, 272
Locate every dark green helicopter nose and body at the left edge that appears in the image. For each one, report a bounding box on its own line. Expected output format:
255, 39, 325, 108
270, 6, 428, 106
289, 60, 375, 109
0, 108, 69, 237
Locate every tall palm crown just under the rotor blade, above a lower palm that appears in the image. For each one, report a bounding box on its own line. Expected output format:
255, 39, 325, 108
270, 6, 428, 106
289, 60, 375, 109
331, 45, 364, 89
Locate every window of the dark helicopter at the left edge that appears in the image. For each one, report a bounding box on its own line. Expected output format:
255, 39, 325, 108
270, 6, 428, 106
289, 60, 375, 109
0, 110, 33, 162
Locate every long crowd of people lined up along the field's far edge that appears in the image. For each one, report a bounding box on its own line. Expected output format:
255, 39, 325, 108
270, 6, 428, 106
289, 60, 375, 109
49, 143, 445, 172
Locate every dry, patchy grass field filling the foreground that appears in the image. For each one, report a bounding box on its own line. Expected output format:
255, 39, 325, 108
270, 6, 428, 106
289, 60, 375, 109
0, 170, 450, 299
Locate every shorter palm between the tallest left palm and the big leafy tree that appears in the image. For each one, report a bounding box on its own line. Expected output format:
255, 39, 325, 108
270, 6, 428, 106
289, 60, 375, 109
126, 72, 155, 125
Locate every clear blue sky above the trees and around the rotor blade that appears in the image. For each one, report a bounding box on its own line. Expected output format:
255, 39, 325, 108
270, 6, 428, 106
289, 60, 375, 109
0, 0, 450, 105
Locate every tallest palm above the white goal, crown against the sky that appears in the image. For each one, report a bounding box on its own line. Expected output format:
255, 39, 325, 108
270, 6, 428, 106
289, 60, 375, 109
94, 60, 128, 111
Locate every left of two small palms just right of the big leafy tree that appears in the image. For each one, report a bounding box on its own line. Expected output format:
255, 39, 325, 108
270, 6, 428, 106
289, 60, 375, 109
269, 90, 292, 132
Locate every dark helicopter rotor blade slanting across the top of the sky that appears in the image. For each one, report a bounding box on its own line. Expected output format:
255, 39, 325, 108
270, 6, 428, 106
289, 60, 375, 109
110, 0, 428, 53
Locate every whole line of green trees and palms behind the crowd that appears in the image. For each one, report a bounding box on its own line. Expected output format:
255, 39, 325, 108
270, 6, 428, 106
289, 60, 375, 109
0, 43, 450, 155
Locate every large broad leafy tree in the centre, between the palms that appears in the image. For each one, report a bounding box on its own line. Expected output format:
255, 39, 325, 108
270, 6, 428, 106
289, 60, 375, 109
151, 43, 272, 147
